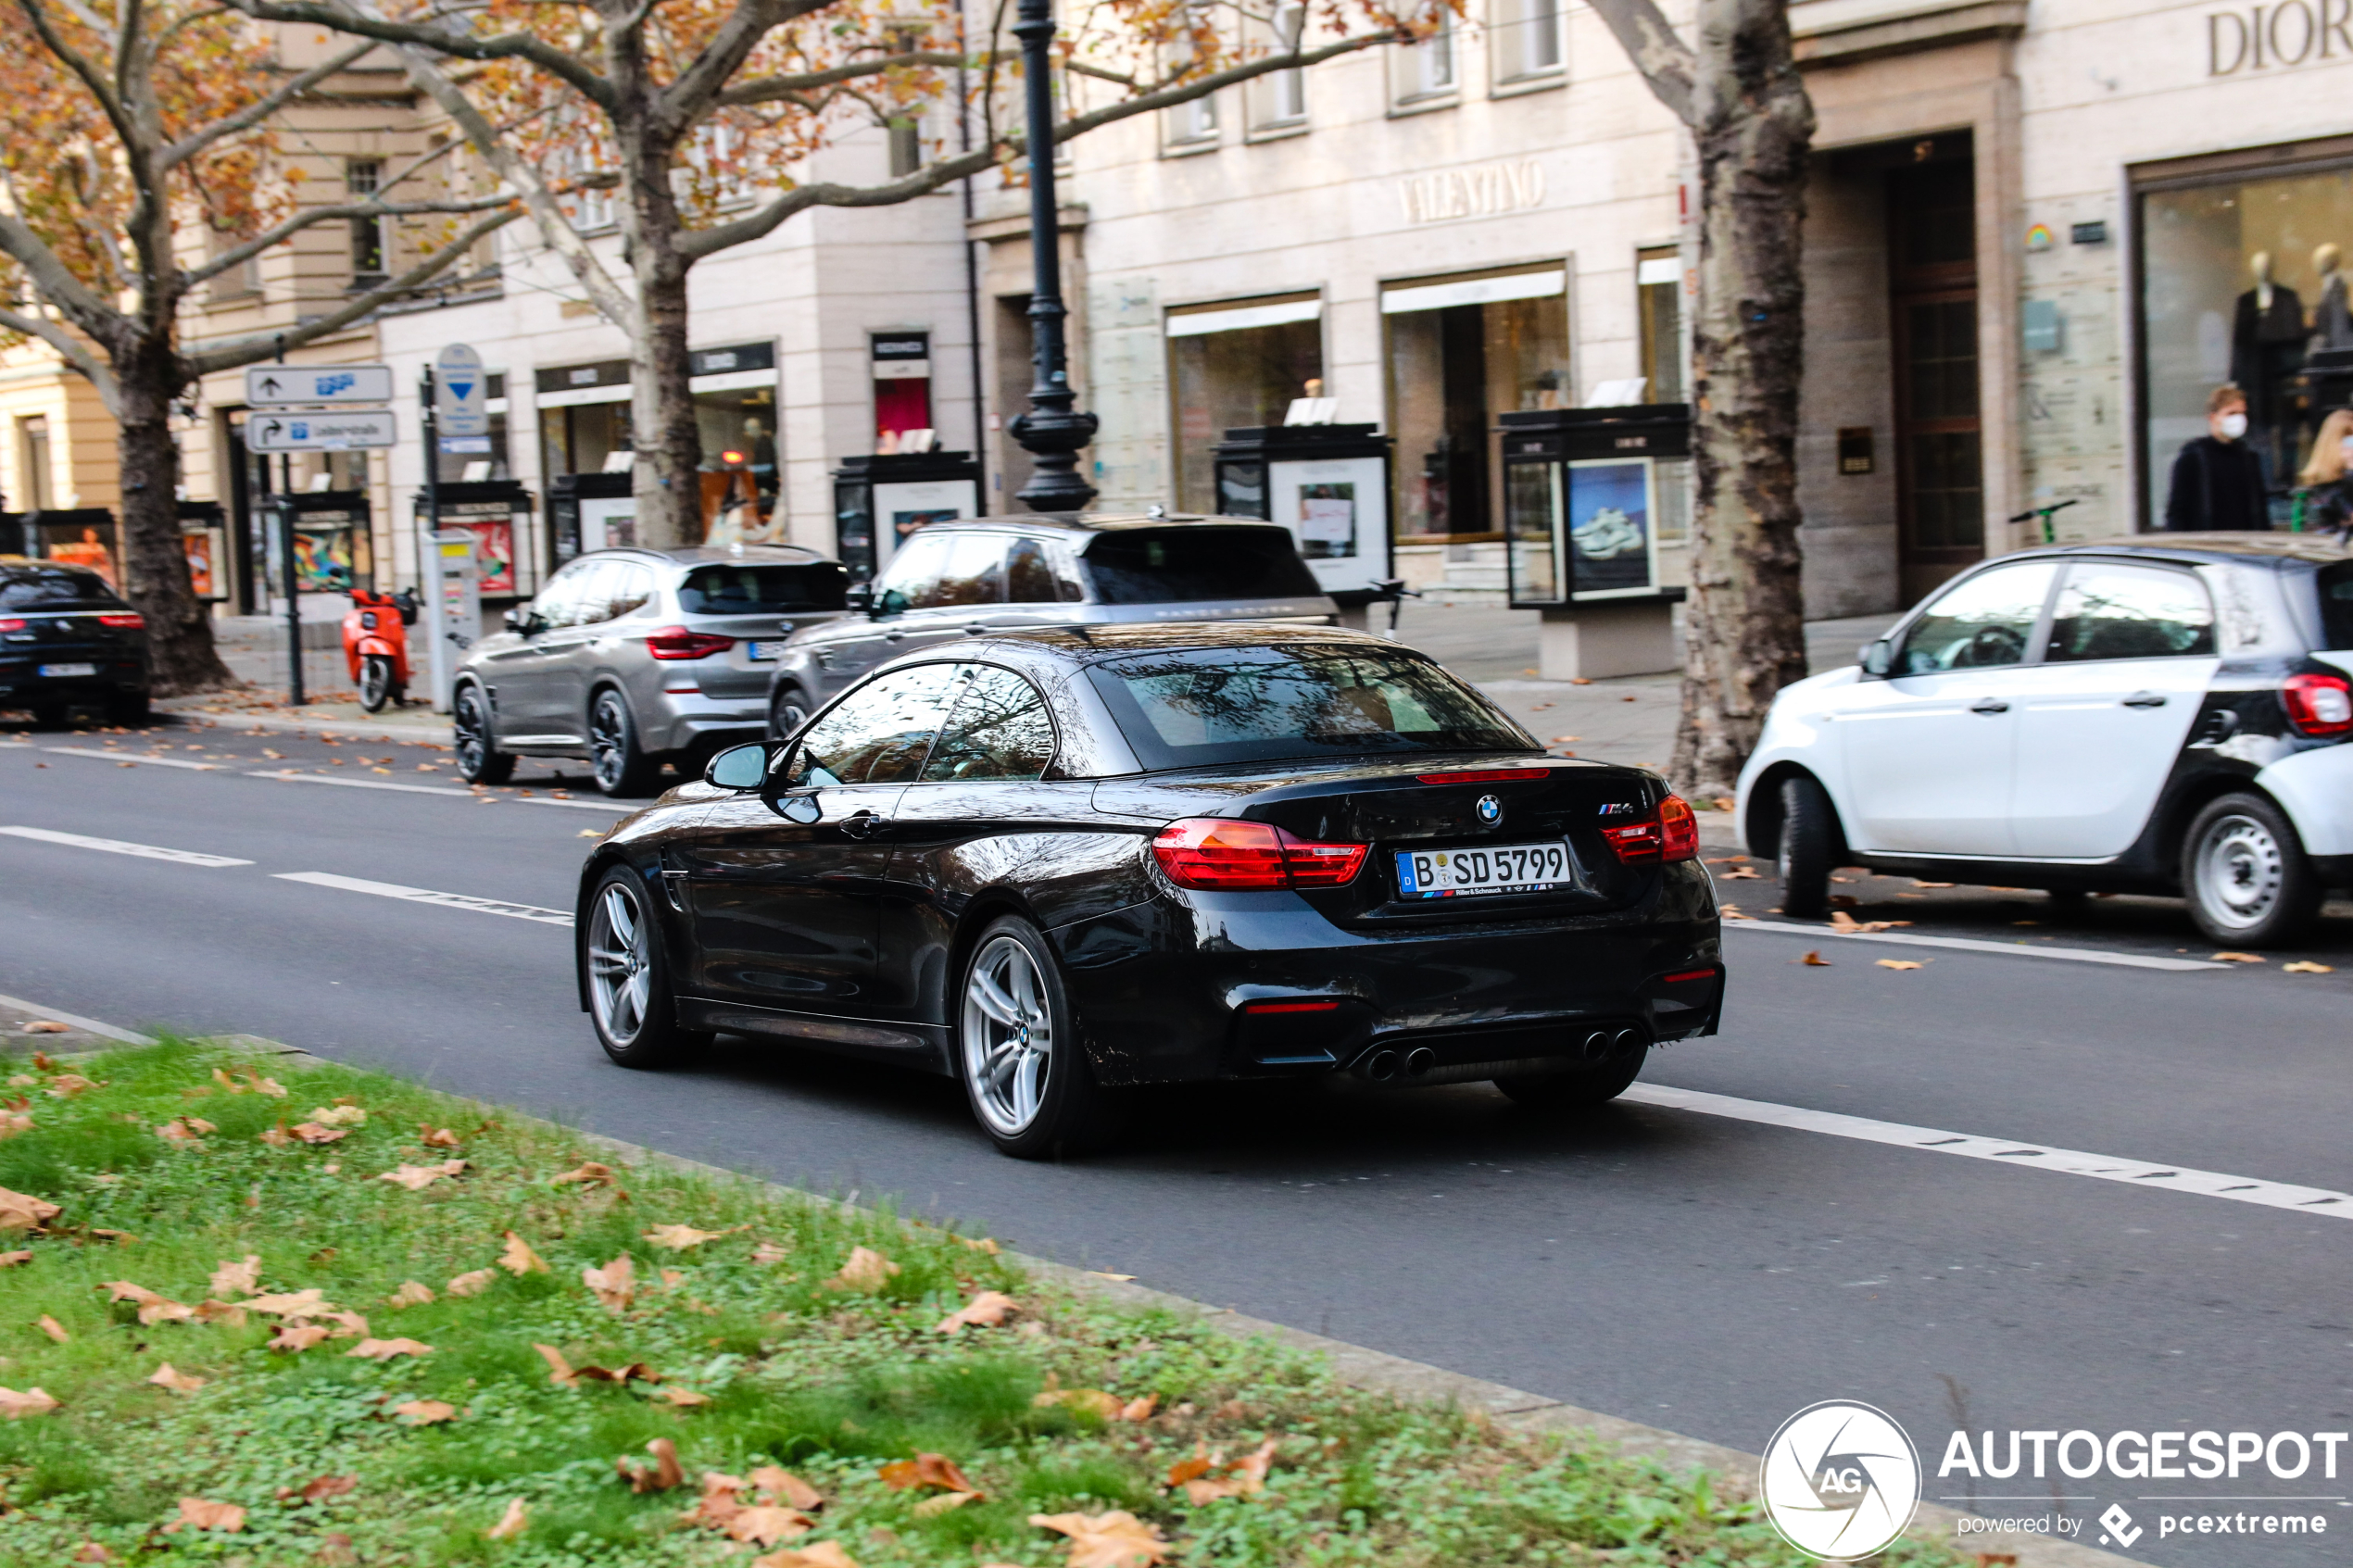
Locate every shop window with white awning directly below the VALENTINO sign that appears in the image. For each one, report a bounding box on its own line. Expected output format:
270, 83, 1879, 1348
1381, 266, 1577, 543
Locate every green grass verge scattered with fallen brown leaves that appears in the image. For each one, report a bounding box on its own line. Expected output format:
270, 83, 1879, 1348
0, 1041, 1953, 1568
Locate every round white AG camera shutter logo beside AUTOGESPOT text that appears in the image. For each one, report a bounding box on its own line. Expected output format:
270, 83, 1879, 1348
1757, 1399, 1920, 1563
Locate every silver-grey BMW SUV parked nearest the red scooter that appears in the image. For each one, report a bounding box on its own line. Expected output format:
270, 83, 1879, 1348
449, 546, 847, 795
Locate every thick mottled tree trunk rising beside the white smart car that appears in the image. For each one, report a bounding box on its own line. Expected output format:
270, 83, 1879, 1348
1670, 0, 1814, 802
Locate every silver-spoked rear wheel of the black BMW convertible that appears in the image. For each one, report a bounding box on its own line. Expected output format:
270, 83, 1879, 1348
958, 914, 1120, 1159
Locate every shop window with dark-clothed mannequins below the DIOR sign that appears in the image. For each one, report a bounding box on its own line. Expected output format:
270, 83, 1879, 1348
2139, 167, 2353, 527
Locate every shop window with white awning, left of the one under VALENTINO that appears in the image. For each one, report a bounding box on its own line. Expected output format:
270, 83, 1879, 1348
1167, 294, 1322, 512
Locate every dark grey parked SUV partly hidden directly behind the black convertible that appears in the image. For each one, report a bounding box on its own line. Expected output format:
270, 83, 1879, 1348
767, 515, 1336, 741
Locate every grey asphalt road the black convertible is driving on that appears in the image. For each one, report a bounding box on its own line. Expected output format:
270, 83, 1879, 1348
0, 726, 2353, 1568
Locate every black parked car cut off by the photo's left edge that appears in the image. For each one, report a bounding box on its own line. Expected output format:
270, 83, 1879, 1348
0, 559, 148, 724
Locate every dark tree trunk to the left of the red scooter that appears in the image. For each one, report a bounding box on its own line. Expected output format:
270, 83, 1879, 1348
115, 350, 235, 696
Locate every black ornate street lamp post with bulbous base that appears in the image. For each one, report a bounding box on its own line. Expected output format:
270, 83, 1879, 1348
1012, 0, 1094, 512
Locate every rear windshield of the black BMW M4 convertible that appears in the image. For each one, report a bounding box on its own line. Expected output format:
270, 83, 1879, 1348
1087, 646, 1543, 769
